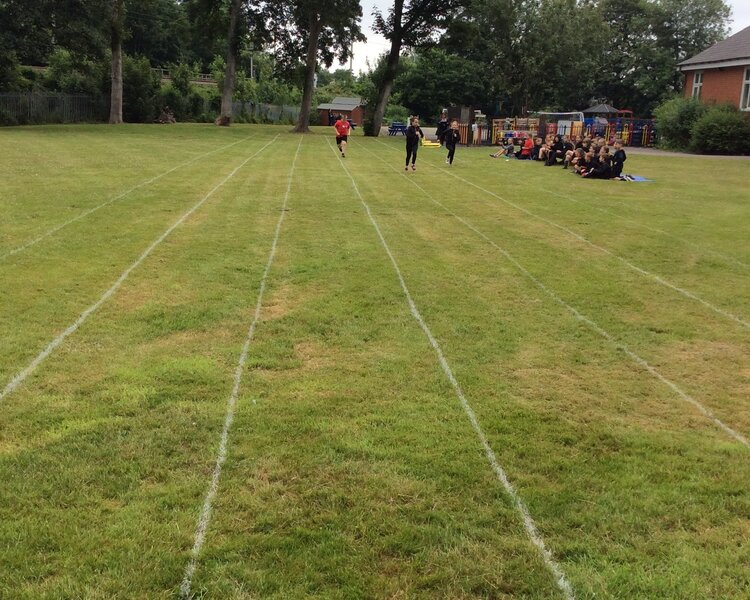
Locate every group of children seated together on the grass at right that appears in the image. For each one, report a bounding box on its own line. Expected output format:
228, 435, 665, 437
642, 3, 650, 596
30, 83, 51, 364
490, 134, 627, 179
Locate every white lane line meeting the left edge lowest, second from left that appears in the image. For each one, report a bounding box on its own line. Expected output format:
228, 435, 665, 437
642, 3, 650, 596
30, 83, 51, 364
0, 135, 279, 401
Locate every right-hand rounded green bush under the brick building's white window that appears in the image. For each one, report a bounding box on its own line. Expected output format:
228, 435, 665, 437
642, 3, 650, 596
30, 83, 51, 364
690, 105, 750, 155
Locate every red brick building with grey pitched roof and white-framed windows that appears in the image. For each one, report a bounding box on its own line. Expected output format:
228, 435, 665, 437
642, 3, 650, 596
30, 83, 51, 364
679, 27, 750, 111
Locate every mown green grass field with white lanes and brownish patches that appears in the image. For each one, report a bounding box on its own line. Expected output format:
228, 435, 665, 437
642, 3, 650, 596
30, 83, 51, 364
0, 125, 750, 600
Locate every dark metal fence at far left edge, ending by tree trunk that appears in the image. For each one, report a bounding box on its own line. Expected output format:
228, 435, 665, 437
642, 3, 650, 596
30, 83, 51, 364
0, 92, 108, 125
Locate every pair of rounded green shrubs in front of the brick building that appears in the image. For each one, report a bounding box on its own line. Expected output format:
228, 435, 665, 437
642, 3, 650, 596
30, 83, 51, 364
654, 98, 750, 155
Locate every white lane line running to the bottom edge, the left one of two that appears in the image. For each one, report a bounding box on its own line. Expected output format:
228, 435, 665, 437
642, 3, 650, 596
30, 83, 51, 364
180, 138, 302, 599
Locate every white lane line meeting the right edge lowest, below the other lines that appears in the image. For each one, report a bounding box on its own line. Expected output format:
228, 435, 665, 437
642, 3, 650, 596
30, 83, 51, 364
358, 145, 750, 448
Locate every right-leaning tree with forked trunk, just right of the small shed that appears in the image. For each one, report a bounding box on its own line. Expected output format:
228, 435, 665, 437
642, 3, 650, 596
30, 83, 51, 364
366, 0, 460, 136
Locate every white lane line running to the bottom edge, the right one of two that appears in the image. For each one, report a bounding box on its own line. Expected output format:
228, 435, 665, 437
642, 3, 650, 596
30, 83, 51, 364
326, 139, 574, 600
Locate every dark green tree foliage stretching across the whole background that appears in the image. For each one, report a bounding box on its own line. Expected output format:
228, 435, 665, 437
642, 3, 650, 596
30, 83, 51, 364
0, 0, 730, 122
